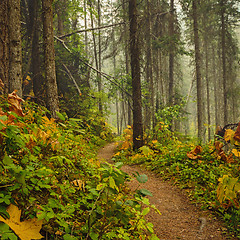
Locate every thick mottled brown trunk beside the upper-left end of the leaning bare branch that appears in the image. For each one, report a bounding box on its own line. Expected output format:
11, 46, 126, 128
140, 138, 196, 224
42, 0, 59, 118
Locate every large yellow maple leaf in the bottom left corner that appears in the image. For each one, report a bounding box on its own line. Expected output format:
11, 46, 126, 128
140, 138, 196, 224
0, 204, 43, 240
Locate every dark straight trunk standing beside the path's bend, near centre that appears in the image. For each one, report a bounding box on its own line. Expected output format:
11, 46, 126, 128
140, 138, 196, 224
129, 0, 143, 149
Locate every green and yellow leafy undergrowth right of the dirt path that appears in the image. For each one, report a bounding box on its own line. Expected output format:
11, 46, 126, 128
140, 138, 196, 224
114, 122, 240, 239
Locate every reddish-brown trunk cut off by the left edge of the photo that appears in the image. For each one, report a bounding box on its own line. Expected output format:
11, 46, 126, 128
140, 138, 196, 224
0, 0, 9, 93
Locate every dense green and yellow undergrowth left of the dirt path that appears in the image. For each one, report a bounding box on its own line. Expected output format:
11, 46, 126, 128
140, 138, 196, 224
0, 94, 161, 240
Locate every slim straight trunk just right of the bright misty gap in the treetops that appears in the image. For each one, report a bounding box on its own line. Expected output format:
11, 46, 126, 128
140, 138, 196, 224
192, 0, 204, 140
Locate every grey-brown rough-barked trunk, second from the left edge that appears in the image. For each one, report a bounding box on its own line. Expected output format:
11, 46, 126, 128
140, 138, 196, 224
8, 0, 22, 97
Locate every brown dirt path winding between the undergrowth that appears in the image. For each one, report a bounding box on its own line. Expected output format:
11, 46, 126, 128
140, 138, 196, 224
98, 143, 236, 240
